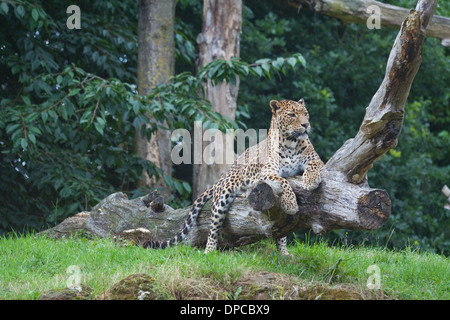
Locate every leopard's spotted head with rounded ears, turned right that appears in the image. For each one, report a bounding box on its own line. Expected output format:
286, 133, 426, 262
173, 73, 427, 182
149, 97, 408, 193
270, 99, 311, 141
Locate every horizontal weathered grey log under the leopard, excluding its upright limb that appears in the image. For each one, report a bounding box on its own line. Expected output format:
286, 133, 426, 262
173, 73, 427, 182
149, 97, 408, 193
38, 176, 391, 247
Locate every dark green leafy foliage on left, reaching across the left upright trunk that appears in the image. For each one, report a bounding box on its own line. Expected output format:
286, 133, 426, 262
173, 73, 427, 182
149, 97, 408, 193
0, 1, 236, 233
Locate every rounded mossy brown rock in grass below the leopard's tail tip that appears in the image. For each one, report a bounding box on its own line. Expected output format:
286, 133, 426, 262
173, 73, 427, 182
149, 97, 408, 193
106, 273, 158, 300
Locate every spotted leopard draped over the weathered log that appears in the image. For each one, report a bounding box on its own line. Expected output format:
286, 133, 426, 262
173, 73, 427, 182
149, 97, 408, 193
143, 98, 324, 255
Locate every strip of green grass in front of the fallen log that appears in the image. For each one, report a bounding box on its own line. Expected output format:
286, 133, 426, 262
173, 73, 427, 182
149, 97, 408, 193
0, 235, 450, 300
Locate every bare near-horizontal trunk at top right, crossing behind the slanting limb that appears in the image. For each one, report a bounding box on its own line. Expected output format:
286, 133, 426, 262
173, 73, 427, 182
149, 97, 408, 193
289, 0, 450, 47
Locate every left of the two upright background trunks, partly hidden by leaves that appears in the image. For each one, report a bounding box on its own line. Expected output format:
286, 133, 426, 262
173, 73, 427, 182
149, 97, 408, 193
136, 0, 175, 190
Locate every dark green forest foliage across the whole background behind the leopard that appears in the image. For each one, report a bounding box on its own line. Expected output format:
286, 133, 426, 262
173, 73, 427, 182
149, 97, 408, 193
0, 0, 450, 255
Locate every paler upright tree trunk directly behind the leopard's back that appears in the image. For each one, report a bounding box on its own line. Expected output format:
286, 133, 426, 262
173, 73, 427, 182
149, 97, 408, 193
192, 0, 242, 198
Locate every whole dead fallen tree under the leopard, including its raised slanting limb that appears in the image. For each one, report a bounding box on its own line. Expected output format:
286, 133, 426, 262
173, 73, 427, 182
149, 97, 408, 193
41, 0, 437, 247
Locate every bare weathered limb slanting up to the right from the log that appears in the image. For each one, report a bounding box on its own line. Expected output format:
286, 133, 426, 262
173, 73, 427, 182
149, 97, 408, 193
324, 1, 436, 183
